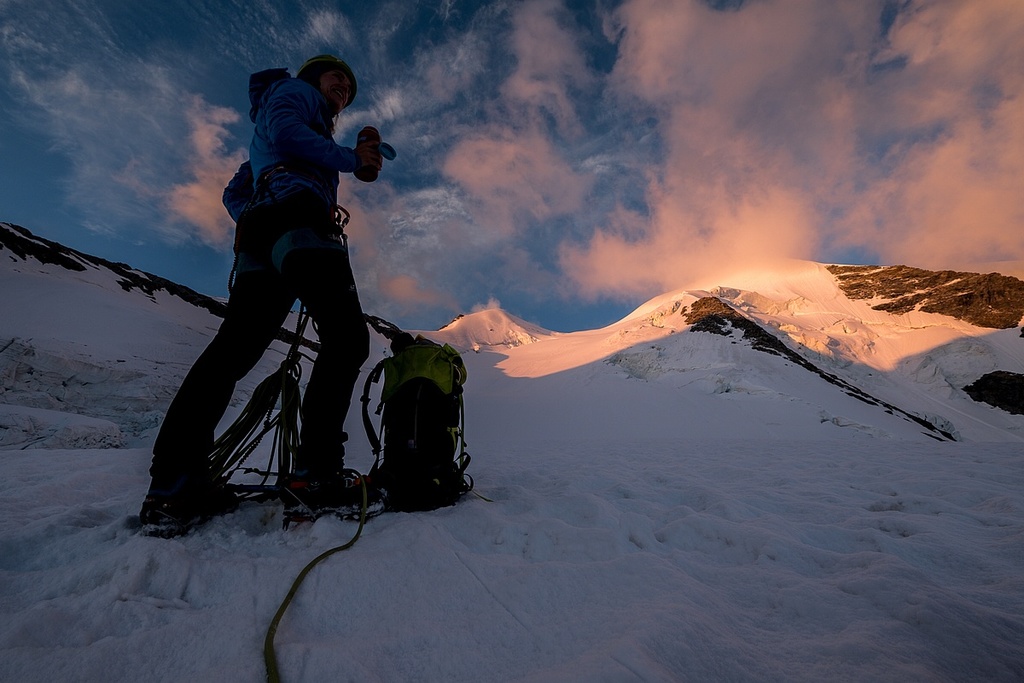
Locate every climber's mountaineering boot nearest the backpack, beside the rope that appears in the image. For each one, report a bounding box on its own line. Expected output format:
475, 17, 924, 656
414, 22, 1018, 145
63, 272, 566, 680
281, 469, 384, 527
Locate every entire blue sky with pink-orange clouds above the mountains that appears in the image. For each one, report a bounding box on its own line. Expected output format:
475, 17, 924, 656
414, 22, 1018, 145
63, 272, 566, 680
0, 0, 1024, 332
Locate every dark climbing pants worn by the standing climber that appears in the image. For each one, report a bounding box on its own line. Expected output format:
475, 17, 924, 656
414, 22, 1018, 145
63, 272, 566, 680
150, 230, 370, 489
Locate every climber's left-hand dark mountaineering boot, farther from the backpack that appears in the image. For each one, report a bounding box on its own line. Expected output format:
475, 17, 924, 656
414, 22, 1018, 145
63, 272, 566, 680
138, 475, 239, 539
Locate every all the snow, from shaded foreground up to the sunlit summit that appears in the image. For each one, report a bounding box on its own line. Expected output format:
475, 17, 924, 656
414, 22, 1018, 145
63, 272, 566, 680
0, 227, 1024, 682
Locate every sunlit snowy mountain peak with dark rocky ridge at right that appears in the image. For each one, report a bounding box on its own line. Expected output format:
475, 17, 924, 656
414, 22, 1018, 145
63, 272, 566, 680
479, 261, 1024, 439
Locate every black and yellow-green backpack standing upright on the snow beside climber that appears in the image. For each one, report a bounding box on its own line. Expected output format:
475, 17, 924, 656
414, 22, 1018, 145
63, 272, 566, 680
361, 332, 473, 512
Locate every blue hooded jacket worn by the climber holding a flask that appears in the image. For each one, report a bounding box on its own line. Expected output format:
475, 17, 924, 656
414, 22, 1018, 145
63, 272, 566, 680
223, 69, 359, 221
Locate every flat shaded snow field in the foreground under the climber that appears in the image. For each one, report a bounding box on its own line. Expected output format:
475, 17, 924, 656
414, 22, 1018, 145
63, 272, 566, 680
0, 438, 1024, 681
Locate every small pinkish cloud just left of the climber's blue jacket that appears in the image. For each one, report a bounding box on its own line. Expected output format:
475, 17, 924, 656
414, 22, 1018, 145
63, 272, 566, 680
166, 96, 245, 246
